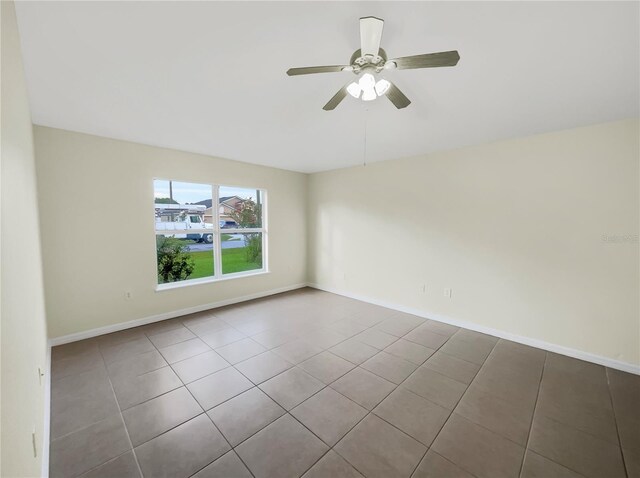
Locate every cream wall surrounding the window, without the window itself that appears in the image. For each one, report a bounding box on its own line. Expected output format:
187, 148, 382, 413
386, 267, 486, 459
35, 127, 307, 337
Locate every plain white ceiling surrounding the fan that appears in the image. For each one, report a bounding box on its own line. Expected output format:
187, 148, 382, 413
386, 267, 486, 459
17, 1, 640, 172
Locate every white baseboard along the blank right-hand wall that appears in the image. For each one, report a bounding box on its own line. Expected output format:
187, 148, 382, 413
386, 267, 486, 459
307, 283, 640, 375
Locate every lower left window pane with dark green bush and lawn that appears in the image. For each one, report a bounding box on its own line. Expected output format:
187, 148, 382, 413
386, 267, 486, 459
156, 234, 214, 284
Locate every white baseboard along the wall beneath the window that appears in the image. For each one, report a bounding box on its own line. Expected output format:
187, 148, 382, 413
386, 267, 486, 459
49, 283, 307, 347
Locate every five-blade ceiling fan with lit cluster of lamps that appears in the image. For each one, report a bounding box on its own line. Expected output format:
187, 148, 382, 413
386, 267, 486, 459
287, 17, 460, 111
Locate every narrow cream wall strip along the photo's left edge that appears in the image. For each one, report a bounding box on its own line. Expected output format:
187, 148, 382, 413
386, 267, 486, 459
0, 1, 47, 477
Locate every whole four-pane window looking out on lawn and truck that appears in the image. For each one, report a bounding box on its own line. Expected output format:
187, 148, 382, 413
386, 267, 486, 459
154, 179, 267, 286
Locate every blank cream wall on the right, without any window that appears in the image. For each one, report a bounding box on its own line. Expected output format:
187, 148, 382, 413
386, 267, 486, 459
308, 120, 640, 364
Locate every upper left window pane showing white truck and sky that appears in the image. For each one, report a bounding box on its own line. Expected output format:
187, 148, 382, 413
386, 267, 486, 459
153, 179, 213, 232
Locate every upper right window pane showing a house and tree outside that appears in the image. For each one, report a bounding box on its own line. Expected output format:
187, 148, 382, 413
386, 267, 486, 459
218, 186, 264, 228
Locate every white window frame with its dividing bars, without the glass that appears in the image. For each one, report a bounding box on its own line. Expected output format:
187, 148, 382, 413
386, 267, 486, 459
152, 178, 269, 291
